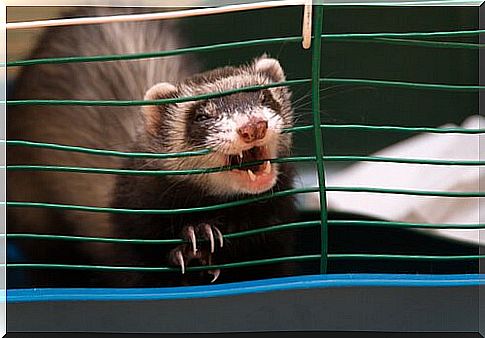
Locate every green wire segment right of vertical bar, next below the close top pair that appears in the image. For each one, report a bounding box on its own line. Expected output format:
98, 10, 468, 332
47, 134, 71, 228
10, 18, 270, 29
320, 77, 485, 92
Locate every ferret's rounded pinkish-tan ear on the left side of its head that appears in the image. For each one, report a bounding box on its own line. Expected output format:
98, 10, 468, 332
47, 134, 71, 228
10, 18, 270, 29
142, 82, 177, 135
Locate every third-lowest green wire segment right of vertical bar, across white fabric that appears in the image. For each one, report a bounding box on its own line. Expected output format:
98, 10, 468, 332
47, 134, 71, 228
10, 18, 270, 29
327, 187, 485, 197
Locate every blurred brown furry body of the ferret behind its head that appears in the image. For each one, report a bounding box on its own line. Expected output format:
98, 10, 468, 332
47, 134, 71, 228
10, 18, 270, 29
7, 8, 196, 238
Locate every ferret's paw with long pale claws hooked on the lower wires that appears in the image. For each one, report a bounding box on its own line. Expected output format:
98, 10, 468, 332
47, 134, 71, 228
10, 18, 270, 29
169, 223, 224, 283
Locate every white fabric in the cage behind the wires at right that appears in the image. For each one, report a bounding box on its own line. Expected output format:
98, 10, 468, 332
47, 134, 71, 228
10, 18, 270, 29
306, 116, 485, 244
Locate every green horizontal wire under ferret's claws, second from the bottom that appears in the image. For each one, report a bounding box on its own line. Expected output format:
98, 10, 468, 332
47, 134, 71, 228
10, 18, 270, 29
7, 220, 485, 245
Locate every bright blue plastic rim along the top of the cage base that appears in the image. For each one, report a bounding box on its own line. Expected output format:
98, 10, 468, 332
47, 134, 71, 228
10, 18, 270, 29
7, 274, 485, 303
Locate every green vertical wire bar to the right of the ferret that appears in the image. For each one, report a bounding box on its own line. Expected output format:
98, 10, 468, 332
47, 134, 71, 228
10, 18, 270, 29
312, 5, 328, 273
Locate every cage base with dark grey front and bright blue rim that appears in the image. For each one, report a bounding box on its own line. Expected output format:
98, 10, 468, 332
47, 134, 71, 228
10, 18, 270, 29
7, 274, 485, 333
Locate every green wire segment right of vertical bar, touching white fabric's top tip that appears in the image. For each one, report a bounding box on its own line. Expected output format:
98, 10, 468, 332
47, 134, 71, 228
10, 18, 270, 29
321, 124, 485, 134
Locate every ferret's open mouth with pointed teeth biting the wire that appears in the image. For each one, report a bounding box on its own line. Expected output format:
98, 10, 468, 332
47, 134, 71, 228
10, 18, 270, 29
228, 146, 271, 182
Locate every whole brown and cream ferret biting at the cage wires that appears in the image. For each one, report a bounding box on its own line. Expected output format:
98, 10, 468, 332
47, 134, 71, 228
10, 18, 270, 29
7, 8, 296, 287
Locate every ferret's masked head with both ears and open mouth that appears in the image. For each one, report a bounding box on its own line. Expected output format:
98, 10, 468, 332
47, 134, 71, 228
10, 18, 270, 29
143, 56, 293, 195
